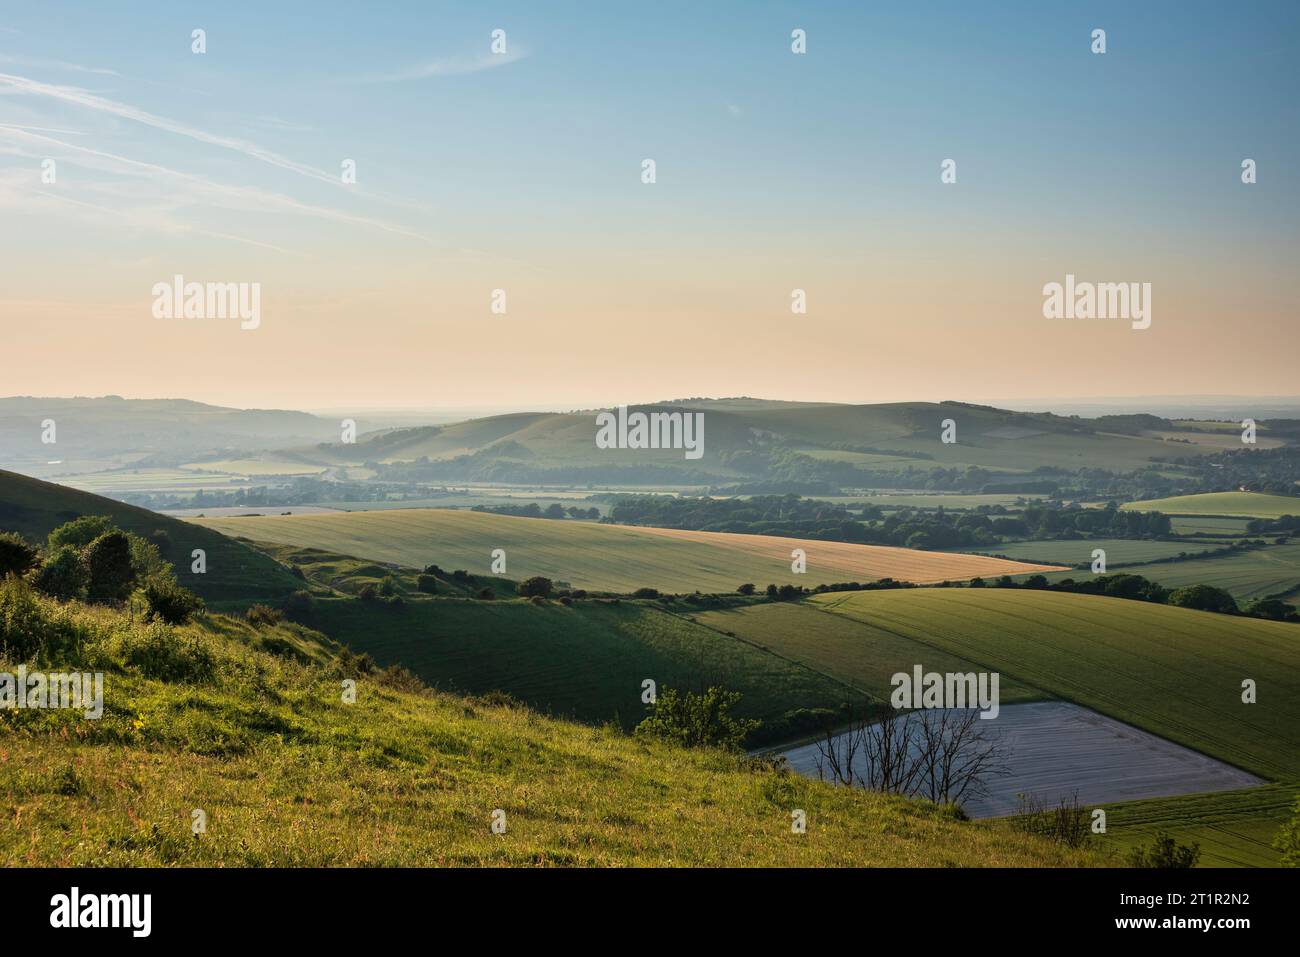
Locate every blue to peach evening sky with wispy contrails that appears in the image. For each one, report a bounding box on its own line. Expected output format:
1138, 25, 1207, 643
0, 0, 1300, 408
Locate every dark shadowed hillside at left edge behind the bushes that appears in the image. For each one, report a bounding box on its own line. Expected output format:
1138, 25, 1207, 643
0, 471, 302, 605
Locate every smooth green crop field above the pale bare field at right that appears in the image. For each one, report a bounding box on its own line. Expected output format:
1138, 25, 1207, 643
810, 589, 1300, 779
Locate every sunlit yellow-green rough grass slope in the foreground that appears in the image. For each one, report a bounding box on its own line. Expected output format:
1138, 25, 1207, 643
0, 590, 1101, 866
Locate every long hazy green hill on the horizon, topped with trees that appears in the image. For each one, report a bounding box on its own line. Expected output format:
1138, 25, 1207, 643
284, 402, 1214, 480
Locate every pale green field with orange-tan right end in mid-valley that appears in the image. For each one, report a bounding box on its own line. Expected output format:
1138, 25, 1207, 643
196, 508, 1056, 592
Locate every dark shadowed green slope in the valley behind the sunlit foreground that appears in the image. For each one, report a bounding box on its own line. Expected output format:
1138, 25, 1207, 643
304, 598, 852, 744
